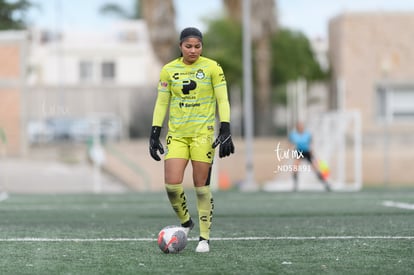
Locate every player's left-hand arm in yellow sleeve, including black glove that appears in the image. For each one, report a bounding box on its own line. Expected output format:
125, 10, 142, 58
149, 70, 171, 161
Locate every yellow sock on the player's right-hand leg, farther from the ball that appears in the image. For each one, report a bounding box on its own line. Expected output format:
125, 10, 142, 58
195, 186, 214, 240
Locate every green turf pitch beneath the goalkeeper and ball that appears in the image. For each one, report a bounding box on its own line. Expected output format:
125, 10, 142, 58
0, 189, 414, 274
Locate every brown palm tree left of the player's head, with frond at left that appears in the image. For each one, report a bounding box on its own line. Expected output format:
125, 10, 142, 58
100, 0, 177, 63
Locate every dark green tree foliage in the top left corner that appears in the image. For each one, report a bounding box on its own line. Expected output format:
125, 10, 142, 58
0, 0, 33, 30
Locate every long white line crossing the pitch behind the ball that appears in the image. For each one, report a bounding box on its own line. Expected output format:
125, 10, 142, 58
0, 236, 414, 242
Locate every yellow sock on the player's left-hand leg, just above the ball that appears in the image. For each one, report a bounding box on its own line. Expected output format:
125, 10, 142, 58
165, 184, 190, 224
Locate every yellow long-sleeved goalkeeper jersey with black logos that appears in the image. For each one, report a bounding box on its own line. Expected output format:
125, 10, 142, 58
152, 56, 230, 137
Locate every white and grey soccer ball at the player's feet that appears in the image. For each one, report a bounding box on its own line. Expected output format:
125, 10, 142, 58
158, 225, 187, 253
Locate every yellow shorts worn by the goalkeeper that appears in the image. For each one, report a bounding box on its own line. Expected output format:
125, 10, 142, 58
164, 134, 214, 163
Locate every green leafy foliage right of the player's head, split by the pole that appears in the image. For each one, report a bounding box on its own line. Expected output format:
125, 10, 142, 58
203, 19, 327, 105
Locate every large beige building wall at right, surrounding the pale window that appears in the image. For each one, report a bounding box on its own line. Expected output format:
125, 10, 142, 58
329, 12, 414, 184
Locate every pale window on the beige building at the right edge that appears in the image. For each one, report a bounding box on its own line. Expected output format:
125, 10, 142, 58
377, 83, 414, 122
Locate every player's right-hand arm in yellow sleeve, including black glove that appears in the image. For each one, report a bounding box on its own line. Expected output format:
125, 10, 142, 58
212, 62, 234, 158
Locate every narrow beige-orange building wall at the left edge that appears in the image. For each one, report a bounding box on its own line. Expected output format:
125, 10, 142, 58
0, 31, 26, 155
